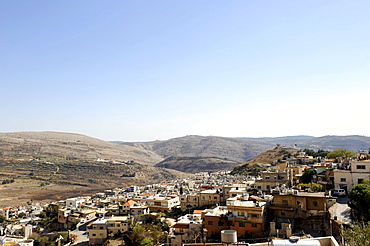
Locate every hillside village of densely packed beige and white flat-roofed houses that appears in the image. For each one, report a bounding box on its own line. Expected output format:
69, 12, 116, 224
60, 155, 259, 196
0, 147, 370, 246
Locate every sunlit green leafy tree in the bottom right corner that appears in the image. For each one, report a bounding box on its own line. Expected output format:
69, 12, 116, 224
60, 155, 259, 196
341, 223, 370, 246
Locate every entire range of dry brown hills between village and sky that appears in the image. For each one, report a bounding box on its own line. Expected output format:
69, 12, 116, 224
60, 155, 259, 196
4, 132, 370, 207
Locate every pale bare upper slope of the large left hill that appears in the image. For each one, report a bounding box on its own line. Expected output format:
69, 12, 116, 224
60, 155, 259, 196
0, 132, 163, 165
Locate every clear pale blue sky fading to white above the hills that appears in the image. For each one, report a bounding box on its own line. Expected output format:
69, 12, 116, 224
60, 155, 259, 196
0, 0, 370, 141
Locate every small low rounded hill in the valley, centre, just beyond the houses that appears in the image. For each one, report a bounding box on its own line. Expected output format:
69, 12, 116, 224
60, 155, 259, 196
155, 156, 240, 173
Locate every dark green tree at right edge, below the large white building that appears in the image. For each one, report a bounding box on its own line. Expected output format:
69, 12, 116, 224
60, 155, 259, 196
348, 180, 370, 221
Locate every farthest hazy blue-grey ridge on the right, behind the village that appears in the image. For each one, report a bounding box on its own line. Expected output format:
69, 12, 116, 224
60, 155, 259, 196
246, 135, 370, 152
